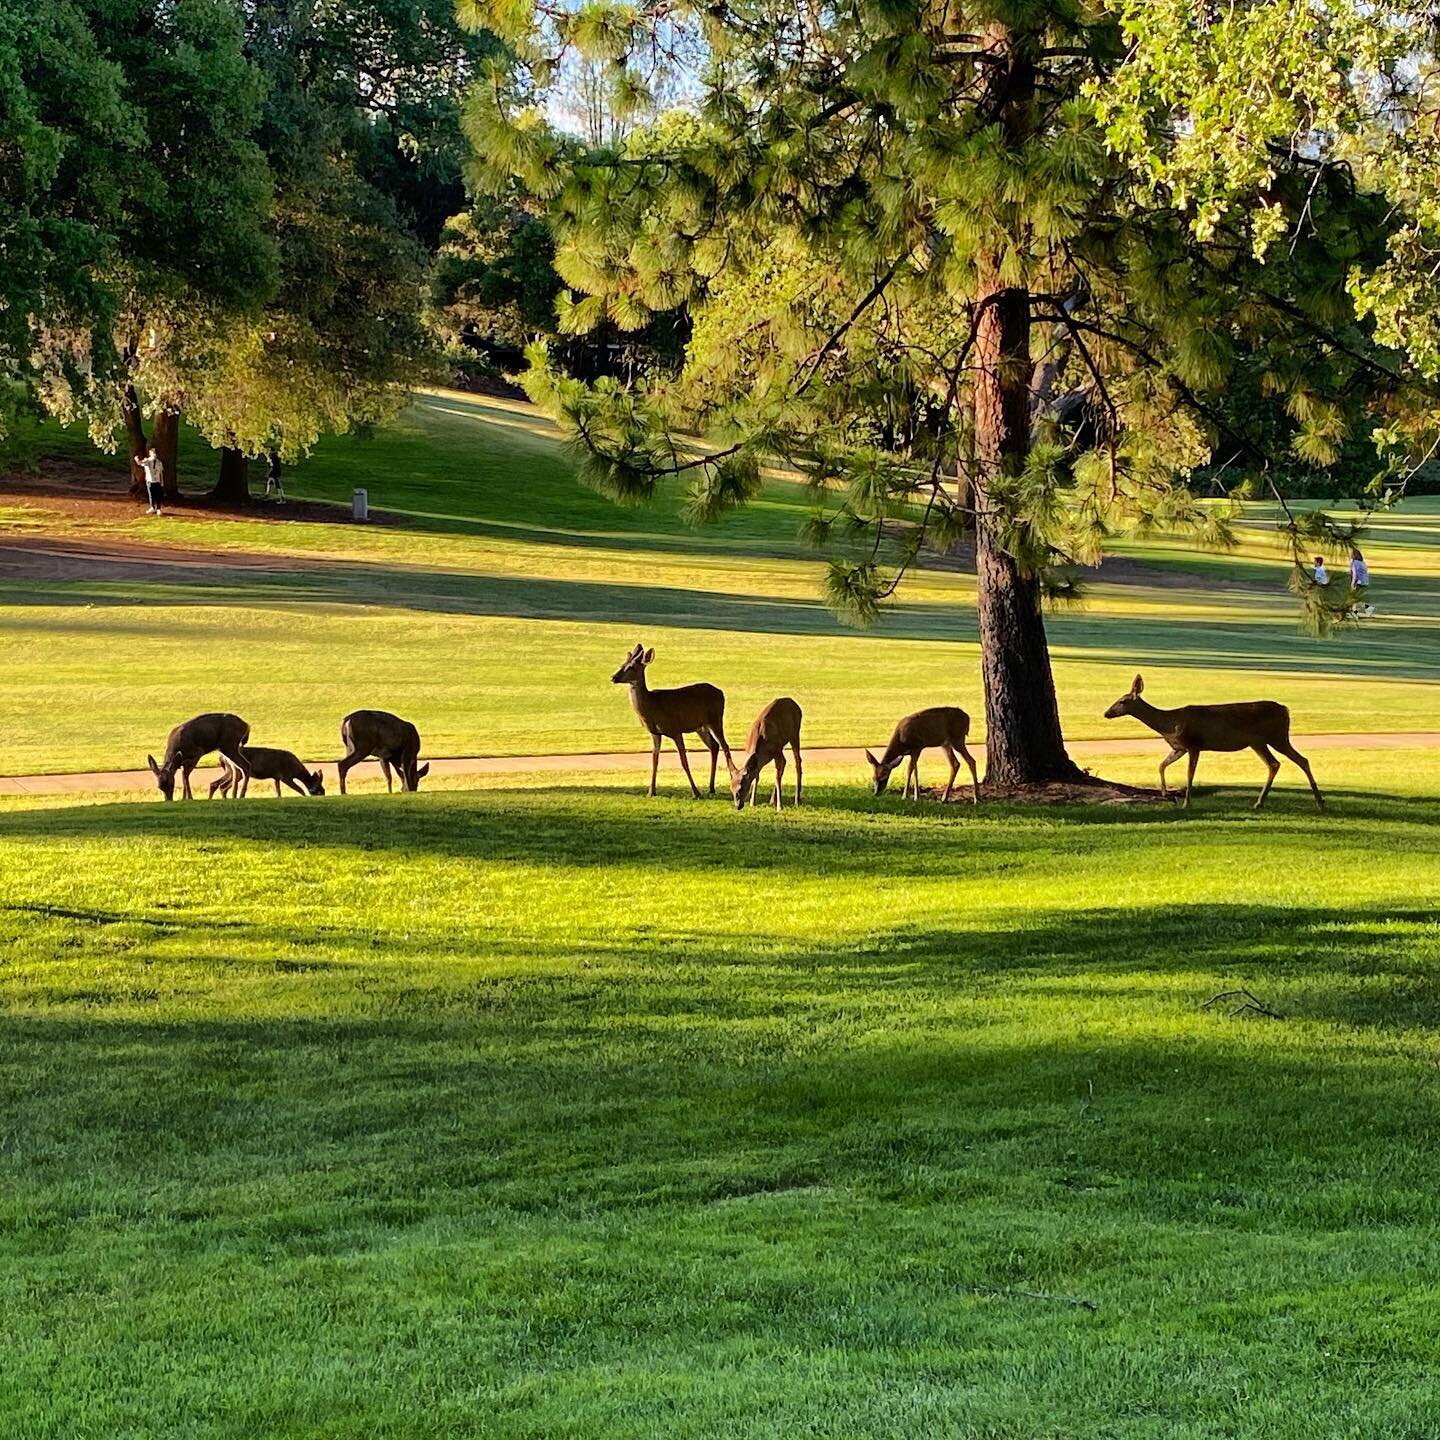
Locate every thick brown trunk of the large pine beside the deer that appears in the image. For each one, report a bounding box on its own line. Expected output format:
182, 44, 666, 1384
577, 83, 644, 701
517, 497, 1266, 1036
973, 26, 1080, 785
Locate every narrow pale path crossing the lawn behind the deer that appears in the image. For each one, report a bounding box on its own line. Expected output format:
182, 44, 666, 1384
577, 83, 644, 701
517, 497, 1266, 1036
0, 730, 1440, 795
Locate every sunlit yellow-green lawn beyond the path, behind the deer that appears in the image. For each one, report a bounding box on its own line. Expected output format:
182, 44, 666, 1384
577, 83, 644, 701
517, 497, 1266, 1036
0, 393, 1440, 773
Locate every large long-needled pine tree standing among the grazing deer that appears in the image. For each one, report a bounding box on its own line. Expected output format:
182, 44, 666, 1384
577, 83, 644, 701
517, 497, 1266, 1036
459, 0, 1440, 783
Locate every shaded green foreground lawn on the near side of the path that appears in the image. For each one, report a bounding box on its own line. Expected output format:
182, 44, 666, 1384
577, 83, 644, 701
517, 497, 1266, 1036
0, 752, 1440, 1440
